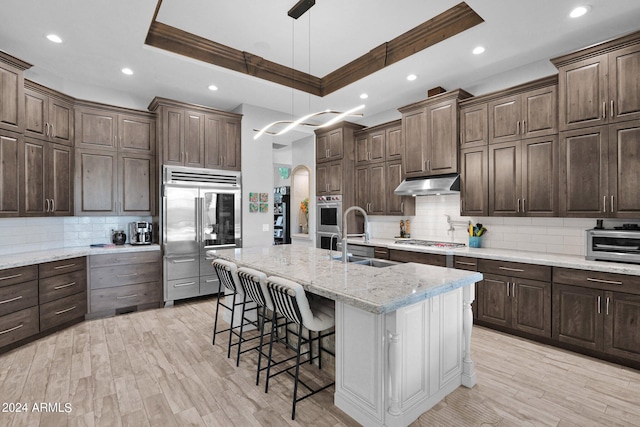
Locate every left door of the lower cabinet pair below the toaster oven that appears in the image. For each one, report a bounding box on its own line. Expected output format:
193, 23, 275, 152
552, 283, 604, 351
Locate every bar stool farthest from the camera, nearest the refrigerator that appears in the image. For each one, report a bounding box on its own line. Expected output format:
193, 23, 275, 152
211, 258, 258, 366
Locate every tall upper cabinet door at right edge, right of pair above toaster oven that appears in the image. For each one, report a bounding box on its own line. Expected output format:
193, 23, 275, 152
608, 121, 640, 218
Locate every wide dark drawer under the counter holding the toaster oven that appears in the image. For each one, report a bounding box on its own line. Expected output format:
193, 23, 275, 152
553, 267, 640, 294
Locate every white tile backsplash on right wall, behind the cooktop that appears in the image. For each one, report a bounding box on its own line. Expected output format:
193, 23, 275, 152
369, 194, 640, 256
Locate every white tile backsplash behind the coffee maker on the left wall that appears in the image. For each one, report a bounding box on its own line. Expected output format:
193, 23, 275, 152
0, 216, 151, 255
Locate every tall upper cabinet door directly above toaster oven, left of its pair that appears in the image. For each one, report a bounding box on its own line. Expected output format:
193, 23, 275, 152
559, 126, 610, 218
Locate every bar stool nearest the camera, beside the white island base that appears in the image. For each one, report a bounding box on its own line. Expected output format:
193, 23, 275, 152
265, 276, 335, 420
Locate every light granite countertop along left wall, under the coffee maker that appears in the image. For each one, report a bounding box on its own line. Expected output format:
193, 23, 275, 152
0, 245, 160, 270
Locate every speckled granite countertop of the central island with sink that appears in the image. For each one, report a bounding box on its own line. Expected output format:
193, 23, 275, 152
207, 245, 482, 314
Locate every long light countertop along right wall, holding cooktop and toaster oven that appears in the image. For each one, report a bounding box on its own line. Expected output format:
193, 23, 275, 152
347, 239, 640, 276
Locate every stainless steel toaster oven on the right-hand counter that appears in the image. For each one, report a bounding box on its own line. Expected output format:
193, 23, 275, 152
585, 229, 640, 264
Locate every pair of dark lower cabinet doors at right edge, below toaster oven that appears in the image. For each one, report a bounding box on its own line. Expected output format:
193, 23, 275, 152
553, 284, 640, 361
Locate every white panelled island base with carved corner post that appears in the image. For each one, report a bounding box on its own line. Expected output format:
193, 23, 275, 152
334, 284, 476, 426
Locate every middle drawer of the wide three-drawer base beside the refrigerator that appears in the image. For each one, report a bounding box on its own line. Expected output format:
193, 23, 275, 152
90, 263, 160, 289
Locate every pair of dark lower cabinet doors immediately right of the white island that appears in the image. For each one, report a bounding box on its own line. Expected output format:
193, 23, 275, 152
476, 274, 551, 337
